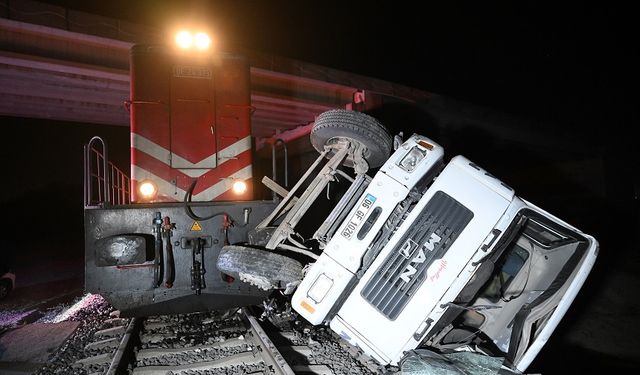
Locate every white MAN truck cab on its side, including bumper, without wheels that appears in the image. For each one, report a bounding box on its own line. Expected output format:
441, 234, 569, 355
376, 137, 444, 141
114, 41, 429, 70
292, 135, 598, 371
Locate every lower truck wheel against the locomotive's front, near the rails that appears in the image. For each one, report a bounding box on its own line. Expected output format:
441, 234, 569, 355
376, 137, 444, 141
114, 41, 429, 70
217, 245, 302, 290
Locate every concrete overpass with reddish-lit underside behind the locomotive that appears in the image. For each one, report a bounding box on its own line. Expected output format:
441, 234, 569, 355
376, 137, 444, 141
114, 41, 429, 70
0, 0, 429, 148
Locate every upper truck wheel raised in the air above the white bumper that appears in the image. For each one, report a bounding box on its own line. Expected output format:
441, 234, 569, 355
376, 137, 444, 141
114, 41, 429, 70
310, 109, 392, 168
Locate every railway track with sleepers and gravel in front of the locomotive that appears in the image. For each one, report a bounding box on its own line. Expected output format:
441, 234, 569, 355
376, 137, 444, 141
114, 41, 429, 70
66, 309, 383, 375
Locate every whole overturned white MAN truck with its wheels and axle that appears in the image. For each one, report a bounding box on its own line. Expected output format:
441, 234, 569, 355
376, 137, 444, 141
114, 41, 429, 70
217, 110, 598, 371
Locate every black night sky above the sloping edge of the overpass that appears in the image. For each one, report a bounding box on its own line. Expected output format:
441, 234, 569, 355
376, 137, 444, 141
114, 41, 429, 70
36, 0, 638, 128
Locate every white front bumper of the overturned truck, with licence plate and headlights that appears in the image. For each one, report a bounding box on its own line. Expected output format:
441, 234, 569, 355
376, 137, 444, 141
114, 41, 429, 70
292, 135, 444, 324
